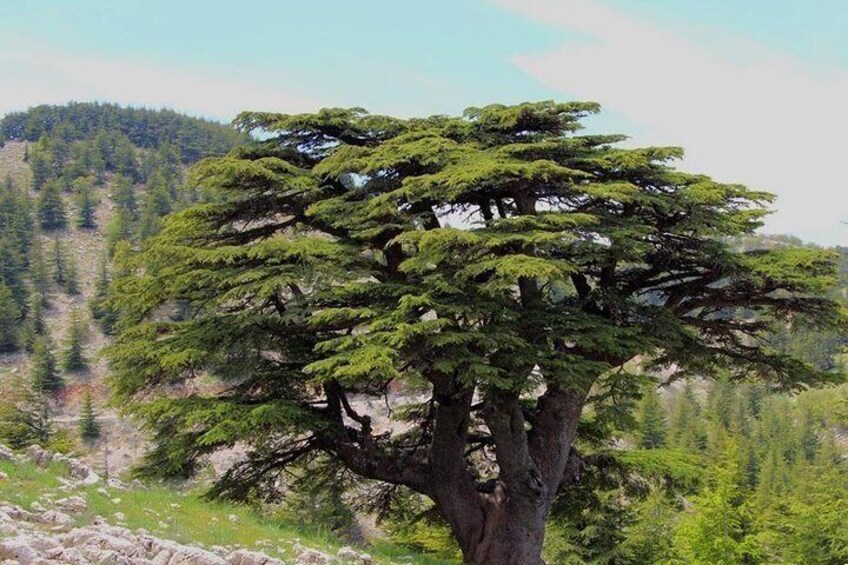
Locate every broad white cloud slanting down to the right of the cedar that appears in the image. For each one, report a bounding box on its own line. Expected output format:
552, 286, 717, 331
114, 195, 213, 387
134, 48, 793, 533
495, 0, 848, 245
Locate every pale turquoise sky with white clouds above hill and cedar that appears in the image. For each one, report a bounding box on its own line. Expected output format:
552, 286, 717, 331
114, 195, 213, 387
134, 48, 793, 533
0, 0, 848, 245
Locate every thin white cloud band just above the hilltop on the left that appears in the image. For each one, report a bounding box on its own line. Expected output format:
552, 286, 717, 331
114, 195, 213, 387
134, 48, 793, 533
0, 37, 321, 120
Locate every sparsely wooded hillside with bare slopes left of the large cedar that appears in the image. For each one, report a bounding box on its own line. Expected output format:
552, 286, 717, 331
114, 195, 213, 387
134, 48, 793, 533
0, 103, 243, 469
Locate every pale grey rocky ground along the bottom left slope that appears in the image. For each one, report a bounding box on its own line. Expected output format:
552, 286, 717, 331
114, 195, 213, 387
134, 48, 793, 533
0, 445, 372, 565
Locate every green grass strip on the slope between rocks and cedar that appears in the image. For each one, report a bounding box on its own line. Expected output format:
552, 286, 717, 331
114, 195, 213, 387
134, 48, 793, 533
0, 461, 453, 565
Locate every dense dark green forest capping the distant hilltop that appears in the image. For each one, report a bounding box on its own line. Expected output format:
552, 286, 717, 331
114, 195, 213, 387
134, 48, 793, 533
0, 102, 244, 163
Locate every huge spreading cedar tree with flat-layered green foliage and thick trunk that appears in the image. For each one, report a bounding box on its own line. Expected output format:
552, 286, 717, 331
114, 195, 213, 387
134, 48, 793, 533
110, 102, 842, 565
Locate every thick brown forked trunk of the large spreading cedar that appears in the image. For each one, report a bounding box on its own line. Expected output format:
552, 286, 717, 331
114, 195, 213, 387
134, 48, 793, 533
431, 388, 585, 565
